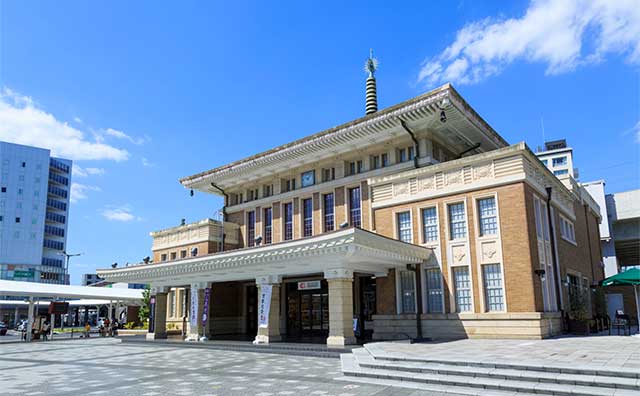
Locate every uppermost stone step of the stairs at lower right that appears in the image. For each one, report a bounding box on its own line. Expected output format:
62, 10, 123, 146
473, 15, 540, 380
364, 343, 640, 379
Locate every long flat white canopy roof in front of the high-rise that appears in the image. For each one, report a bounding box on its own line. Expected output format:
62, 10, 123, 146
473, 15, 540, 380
0, 280, 142, 304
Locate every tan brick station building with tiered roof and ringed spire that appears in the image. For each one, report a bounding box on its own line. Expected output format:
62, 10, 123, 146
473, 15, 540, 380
98, 63, 603, 346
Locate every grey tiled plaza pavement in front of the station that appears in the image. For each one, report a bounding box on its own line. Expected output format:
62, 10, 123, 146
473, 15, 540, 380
0, 339, 460, 396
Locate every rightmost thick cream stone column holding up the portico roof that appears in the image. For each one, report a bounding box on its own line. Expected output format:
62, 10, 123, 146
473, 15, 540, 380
324, 268, 356, 347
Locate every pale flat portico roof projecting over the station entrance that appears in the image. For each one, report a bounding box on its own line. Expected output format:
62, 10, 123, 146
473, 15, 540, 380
97, 228, 432, 286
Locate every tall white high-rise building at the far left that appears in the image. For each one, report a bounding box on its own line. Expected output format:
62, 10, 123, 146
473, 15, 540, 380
0, 142, 71, 284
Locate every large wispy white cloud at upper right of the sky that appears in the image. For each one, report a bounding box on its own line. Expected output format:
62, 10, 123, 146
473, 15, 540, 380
418, 0, 640, 86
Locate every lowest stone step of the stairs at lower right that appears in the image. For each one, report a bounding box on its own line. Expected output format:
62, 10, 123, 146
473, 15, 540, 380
340, 354, 638, 396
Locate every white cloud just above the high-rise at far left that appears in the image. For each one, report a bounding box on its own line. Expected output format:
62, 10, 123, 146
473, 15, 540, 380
0, 88, 129, 161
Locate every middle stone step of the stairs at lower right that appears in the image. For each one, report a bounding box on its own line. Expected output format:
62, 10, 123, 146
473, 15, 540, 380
352, 348, 640, 394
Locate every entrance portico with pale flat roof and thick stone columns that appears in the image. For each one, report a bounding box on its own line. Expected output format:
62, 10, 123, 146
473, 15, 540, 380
98, 228, 431, 346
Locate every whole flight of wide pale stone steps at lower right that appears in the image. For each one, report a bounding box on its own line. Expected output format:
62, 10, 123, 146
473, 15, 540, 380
340, 344, 640, 396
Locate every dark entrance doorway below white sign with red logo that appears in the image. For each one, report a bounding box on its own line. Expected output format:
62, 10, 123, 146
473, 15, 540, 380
286, 279, 329, 342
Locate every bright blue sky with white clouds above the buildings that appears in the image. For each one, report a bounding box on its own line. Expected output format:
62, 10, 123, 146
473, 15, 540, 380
0, 0, 640, 283
